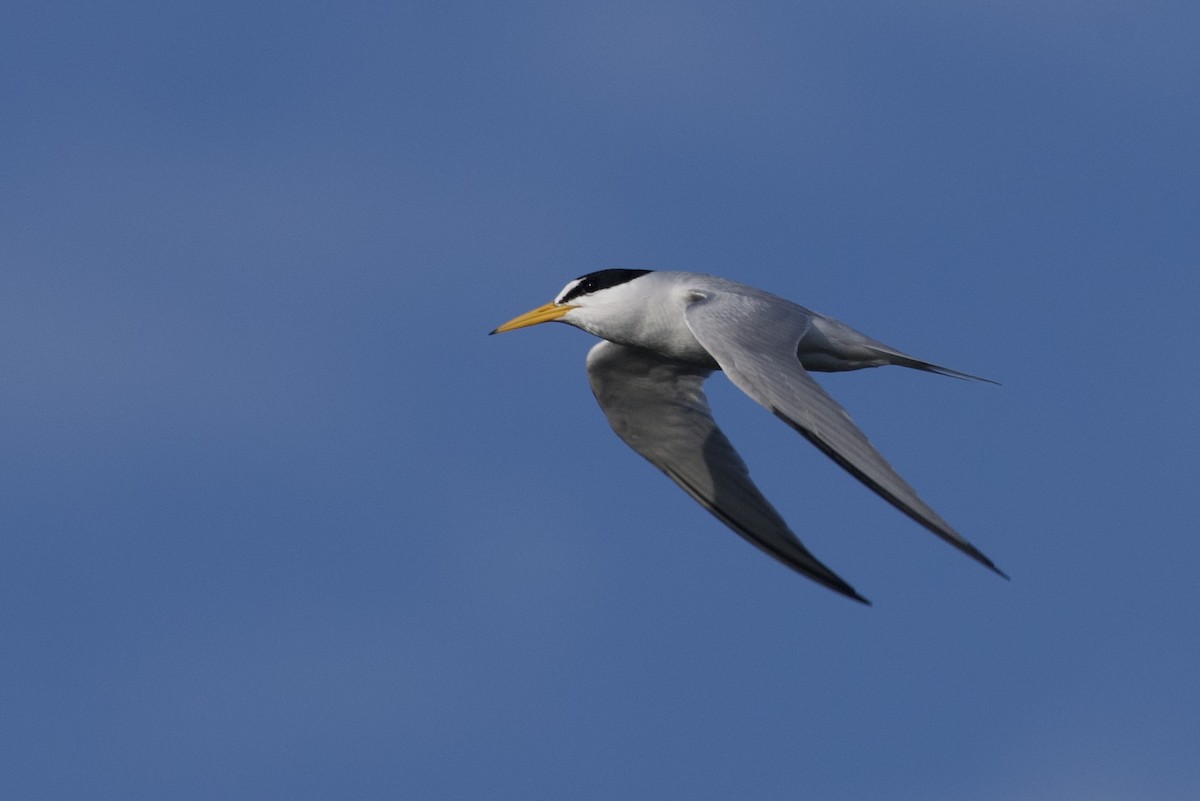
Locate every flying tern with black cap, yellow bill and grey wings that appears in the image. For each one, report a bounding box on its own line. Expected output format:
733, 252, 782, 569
491, 269, 1008, 604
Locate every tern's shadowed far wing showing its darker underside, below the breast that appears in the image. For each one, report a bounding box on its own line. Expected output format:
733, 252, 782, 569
588, 342, 869, 603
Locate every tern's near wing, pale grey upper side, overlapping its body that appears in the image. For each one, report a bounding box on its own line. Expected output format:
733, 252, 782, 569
684, 291, 1008, 578
